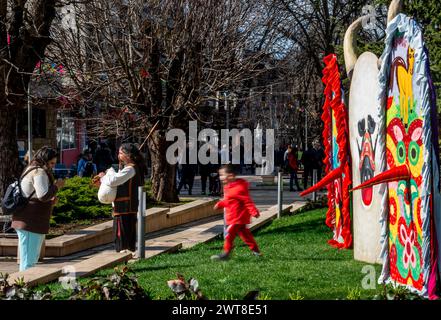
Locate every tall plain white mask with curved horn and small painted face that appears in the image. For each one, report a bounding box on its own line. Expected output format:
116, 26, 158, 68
343, 11, 385, 263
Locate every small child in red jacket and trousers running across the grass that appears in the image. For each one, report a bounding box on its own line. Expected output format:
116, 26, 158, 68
211, 164, 260, 260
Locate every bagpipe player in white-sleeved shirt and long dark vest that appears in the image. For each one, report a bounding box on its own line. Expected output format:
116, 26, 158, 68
99, 143, 146, 252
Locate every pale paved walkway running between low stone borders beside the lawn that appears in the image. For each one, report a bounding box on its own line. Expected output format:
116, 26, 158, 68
0, 176, 305, 280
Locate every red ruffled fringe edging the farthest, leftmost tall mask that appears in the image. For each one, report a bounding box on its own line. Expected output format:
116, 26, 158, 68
321, 54, 352, 248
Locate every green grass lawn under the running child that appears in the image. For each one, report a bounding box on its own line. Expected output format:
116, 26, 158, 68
43, 209, 382, 300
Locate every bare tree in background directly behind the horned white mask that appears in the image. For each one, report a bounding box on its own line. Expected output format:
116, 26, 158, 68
254, 0, 384, 148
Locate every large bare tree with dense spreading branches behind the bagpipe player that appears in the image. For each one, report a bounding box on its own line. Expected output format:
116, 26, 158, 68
51, 0, 280, 201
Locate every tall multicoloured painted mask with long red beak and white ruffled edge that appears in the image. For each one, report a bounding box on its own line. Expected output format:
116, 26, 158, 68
354, 1, 441, 298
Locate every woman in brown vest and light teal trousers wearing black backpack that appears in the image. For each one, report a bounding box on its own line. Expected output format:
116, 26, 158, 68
11, 146, 64, 271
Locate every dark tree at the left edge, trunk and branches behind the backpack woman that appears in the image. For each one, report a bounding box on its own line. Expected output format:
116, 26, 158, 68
0, 0, 56, 195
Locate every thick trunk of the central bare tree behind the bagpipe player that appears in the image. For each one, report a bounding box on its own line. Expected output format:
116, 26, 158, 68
148, 130, 179, 202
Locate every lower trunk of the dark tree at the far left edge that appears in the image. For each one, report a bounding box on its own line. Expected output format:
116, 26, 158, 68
0, 108, 20, 198
